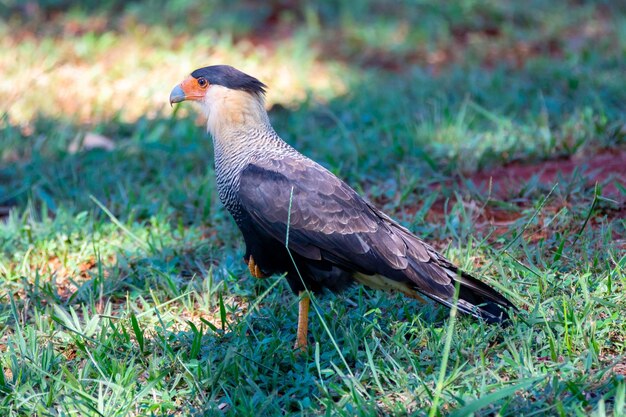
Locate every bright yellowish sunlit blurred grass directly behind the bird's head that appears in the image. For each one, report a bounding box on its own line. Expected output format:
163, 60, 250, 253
0, 22, 347, 123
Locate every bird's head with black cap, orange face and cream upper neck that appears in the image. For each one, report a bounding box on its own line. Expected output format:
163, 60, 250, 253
170, 65, 267, 135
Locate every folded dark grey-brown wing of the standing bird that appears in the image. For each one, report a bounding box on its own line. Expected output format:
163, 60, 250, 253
239, 157, 454, 299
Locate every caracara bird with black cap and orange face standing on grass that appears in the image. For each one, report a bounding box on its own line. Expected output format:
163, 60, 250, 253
169, 65, 516, 350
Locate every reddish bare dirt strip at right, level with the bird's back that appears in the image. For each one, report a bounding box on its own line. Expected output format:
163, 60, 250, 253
469, 149, 626, 204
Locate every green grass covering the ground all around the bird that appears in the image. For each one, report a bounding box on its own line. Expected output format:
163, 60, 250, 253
0, 1, 626, 416
